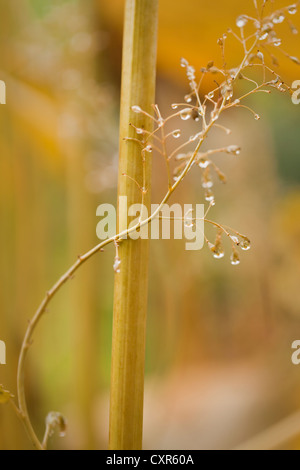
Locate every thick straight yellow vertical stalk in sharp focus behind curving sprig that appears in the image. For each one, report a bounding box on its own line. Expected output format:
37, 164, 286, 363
109, 0, 158, 450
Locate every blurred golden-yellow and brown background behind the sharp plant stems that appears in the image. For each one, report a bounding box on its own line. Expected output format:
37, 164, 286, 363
0, 0, 300, 450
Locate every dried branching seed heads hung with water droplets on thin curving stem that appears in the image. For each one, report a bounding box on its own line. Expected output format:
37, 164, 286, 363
125, 0, 300, 272
